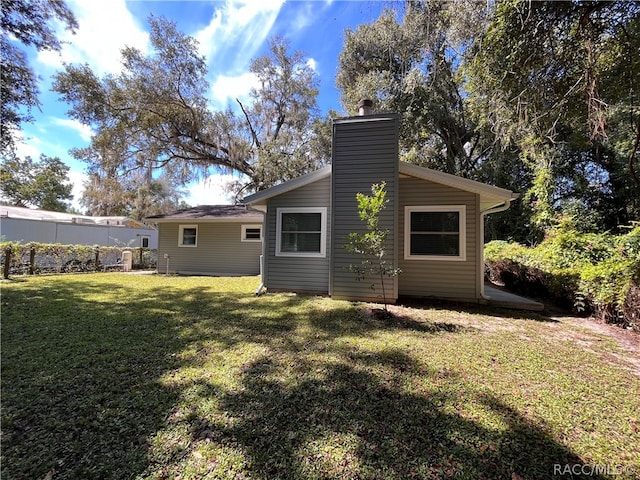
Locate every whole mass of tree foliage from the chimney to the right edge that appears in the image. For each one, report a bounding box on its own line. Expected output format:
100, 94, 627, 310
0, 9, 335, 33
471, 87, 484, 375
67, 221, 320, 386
337, 0, 640, 242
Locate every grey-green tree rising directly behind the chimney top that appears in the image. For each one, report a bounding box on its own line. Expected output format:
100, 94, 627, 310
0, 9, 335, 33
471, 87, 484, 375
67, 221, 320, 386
336, 1, 491, 177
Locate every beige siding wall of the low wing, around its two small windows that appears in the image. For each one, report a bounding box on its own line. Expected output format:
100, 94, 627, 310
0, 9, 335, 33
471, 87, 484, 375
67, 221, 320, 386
158, 220, 262, 275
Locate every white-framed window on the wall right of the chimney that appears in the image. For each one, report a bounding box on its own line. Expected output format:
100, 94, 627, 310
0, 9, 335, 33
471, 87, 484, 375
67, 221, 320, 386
404, 205, 466, 261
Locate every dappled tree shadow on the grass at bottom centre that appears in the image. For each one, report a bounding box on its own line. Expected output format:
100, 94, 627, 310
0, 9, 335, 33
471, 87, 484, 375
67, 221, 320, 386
184, 351, 600, 479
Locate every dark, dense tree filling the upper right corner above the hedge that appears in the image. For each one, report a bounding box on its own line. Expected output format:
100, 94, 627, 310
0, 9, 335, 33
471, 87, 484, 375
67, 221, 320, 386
466, 0, 640, 232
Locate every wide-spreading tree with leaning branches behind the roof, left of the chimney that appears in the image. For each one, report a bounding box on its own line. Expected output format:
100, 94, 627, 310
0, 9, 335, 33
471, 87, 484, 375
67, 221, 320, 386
54, 16, 325, 210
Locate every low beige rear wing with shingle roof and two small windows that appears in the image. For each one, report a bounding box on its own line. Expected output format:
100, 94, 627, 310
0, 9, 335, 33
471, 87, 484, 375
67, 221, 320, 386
146, 205, 263, 276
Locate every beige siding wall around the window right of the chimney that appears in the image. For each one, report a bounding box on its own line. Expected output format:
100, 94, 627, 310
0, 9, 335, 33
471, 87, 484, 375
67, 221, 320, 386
398, 177, 480, 300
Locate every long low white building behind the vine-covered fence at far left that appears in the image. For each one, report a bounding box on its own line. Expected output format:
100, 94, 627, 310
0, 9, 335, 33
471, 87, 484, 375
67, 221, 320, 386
0, 205, 158, 249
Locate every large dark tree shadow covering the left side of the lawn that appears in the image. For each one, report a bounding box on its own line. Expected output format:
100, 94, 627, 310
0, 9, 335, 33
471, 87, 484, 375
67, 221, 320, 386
1, 277, 442, 479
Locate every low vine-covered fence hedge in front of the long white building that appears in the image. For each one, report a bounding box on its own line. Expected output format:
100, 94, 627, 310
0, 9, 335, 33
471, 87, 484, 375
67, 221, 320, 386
0, 242, 157, 275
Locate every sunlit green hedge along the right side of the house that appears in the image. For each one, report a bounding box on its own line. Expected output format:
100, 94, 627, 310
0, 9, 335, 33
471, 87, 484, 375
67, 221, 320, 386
485, 223, 640, 331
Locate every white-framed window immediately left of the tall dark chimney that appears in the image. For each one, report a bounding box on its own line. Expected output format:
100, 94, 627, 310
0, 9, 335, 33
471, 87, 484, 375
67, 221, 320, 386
276, 207, 327, 257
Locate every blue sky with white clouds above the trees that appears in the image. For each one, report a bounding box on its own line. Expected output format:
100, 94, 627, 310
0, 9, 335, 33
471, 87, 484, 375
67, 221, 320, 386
19, 0, 397, 209
